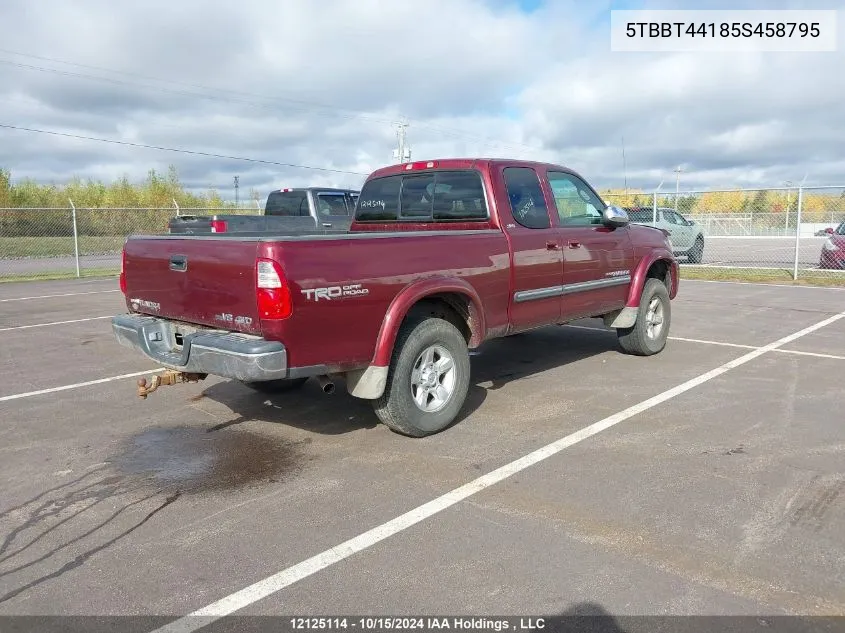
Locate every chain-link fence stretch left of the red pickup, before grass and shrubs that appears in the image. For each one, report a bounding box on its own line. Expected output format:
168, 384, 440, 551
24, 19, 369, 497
0, 206, 261, 281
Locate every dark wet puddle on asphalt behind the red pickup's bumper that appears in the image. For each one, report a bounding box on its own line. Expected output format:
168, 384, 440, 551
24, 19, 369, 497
112, 427, 305, 493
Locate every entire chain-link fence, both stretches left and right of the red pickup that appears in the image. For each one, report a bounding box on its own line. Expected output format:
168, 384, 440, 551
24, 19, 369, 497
0, 186, 845, 283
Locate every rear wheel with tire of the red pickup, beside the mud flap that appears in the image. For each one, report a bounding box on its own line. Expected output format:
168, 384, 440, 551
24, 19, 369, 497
373, 317, 470, 437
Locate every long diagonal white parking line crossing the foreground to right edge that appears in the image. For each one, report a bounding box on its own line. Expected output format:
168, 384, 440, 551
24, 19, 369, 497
153, 312, 845, 633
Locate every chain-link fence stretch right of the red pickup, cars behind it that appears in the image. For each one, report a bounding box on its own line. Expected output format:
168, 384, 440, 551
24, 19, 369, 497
603, 187, 845, 283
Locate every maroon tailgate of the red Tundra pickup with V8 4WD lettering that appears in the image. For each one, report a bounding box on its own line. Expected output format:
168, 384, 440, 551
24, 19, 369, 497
124, 236, 260, 334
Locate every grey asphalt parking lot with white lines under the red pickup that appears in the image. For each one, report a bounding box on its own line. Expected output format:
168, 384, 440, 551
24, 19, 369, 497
0, 279, 845, 618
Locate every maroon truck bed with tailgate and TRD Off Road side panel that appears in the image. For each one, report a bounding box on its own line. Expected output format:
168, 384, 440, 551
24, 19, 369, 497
124, 229, 510, 368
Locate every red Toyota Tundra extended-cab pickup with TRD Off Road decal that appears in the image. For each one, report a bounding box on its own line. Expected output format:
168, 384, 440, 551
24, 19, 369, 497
112, 159, 678, 437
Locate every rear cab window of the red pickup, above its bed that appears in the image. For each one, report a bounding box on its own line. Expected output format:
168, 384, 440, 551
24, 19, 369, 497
356, 170, 488, 222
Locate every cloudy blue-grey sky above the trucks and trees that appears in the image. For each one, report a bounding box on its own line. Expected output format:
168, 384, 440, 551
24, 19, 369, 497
0, 0, 845, 199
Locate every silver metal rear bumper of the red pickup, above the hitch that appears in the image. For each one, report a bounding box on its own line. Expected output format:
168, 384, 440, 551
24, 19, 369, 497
112, 314, 288, 381
